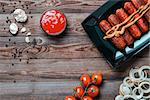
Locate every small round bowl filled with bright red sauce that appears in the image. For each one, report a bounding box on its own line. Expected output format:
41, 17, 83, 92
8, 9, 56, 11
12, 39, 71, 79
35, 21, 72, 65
40, 10, 67, 36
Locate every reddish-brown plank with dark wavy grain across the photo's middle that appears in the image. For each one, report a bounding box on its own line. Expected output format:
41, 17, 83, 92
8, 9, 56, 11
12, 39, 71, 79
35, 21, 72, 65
0, 44, 149, 59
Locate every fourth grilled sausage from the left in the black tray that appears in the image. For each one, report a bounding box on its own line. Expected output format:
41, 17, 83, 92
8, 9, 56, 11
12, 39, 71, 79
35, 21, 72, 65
124, 2, 148, 32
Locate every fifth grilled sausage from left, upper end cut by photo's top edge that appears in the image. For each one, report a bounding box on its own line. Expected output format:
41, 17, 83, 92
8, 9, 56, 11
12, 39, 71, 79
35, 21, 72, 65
131, 0, 150, 23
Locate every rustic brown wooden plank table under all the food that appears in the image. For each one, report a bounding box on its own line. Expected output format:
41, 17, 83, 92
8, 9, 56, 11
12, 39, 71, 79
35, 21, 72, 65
0, 0, 150, 100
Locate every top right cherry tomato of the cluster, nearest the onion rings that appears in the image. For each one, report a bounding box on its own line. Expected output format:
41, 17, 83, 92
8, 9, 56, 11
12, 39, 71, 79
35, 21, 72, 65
92, 73, 103, 85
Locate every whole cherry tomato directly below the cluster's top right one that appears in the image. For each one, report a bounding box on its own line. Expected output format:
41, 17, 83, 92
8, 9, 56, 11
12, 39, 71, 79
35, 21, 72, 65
87, 85, 99, 98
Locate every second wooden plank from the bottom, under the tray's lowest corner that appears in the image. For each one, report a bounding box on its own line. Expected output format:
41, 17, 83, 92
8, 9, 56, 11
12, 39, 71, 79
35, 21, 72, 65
0, 58, 149, 82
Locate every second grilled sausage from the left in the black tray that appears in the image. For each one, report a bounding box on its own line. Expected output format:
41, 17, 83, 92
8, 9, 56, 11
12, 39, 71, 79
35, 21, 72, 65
108, 14, 134, 45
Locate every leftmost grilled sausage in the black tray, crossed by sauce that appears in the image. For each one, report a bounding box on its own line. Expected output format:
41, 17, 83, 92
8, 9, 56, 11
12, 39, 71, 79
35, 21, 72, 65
99, 20, 126, 50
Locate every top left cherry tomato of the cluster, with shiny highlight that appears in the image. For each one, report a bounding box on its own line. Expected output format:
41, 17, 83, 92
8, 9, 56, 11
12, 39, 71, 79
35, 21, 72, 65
80, 74, 91, 87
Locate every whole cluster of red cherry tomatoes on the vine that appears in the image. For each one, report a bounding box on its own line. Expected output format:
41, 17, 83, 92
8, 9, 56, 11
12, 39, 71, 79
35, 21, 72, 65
64, 73, 103, 100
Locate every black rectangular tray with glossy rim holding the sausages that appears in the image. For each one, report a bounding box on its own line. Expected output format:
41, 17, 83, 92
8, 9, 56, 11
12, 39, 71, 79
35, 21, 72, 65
82, 0, 150, 69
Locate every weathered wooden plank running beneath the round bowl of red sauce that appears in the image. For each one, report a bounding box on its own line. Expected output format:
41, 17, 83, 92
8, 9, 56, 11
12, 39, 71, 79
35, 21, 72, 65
0, 13, 89, 37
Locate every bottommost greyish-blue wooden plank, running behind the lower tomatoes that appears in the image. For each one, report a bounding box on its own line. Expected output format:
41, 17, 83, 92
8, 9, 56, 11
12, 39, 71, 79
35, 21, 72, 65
0, 81, 121, 100
